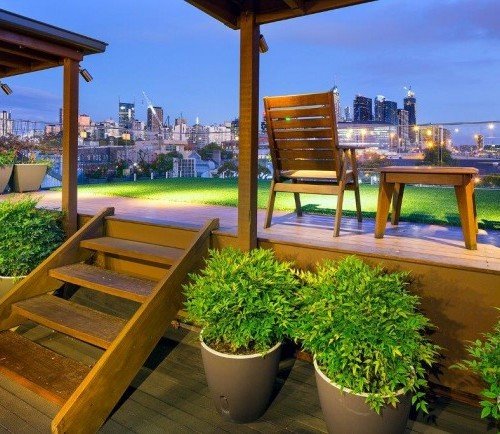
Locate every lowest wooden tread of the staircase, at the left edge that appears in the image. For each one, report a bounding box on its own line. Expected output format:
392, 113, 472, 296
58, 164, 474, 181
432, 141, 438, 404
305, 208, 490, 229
0, 331, 90, 405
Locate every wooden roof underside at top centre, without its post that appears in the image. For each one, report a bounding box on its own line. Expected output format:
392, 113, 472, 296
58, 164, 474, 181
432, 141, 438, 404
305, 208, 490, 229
186, 0, 376, 29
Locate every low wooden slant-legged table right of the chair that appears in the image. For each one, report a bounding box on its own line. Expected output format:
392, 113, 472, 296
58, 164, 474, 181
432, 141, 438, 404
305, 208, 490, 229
375, 166, 478, 250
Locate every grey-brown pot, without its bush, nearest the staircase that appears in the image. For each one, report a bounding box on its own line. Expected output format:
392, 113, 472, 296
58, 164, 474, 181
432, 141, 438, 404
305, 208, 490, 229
201, 340, 281, 423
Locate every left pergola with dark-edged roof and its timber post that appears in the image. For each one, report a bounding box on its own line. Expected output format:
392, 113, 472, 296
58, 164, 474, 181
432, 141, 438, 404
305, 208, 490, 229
0, 9, 107, 236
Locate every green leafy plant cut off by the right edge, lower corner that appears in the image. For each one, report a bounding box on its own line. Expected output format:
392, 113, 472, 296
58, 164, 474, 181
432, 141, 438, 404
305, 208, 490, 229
453, 321, 500, 420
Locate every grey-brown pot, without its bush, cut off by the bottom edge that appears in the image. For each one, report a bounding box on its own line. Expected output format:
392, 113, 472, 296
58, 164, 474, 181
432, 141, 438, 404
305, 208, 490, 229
314, 360, 411, 434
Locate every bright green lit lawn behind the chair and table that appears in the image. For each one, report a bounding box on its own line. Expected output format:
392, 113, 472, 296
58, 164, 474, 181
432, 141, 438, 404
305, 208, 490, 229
75, 178, 500, 229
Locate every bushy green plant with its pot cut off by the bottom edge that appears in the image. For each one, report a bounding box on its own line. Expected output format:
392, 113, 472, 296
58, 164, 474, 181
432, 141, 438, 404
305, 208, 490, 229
292, 257, 438, 434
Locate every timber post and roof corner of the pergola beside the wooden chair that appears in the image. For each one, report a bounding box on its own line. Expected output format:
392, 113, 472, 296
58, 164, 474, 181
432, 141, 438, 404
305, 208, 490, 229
185, 0, 375, 250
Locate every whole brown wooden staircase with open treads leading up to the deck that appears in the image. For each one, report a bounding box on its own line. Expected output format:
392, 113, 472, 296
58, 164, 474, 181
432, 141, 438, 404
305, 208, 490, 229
0, 208, 218, 433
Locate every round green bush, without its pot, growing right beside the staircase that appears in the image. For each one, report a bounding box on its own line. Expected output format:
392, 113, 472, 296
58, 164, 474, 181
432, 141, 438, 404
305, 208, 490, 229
184, 248, 300, 354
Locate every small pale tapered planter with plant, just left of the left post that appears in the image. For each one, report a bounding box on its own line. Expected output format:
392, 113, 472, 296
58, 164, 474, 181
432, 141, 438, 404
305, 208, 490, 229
12, 152, 51, 193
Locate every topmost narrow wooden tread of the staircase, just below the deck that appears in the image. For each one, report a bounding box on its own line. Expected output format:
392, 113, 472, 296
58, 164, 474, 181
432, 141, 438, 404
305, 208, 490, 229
80, 237, 184, 265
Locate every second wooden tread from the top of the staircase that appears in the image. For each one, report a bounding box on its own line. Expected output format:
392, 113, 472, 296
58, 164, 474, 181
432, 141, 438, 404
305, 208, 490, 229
49, 263, 156, 303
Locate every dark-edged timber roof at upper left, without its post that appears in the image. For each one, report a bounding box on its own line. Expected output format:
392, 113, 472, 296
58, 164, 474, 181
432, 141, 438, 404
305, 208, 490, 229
0, 9, 107, 78
